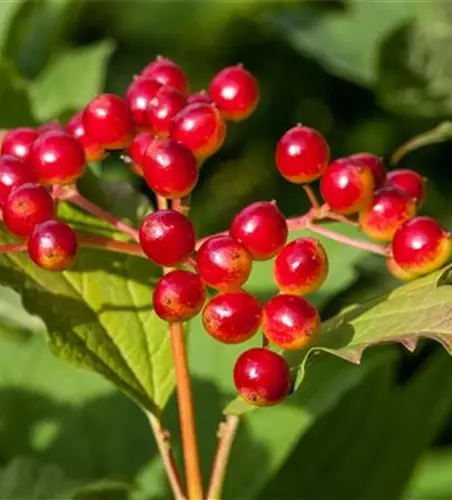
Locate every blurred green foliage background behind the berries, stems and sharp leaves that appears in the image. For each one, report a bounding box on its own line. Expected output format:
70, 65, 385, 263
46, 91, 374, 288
0, 0, 452, 500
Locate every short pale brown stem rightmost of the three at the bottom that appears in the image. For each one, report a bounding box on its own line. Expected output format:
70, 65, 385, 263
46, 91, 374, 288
207, 415, 240, 500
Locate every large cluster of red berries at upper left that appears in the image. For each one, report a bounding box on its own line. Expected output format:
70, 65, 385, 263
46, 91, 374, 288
0, 57, 259, 271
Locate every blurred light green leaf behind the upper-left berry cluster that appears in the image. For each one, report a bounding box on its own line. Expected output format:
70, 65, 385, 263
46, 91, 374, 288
30, 41, 114, 121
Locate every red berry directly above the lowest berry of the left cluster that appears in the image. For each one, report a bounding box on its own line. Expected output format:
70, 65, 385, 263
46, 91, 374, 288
3, 183, 55, 237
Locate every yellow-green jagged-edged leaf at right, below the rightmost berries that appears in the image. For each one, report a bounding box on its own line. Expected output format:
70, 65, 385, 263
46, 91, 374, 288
226, 267, 452, 414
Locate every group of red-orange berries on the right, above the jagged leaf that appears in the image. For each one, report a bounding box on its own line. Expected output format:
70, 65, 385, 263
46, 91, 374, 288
276, 125, 451, 280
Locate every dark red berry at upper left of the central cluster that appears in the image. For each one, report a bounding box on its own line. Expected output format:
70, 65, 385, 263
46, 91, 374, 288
139, 210, 196, 267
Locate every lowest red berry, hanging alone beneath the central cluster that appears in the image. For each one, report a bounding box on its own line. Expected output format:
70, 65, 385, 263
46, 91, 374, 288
234, 347, 292, 406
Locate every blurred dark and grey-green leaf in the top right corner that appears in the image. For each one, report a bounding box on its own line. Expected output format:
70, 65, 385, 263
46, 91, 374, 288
377, 2, 452, 118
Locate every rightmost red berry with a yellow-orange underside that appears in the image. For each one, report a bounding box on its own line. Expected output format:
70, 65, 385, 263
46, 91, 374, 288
392, 217, 452, 276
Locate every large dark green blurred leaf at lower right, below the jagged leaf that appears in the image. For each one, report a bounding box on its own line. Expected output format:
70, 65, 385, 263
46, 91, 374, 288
262, 351, 452, 500
